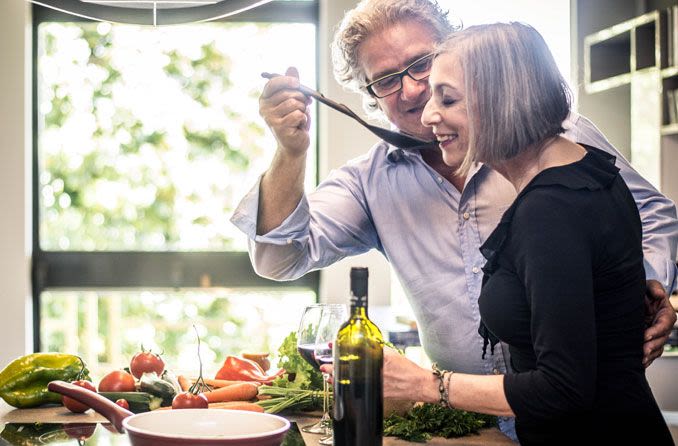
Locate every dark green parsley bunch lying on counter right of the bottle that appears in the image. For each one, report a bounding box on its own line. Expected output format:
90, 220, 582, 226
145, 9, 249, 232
384, 403, 497, 443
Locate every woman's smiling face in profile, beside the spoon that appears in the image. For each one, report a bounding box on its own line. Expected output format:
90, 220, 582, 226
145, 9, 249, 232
421, 53, 468, 168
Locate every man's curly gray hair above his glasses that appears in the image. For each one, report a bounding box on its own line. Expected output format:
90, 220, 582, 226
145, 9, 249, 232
331, 0, 457, 117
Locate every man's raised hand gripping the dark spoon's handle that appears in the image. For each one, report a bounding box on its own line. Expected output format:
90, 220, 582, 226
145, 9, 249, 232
259, 67, 311, 157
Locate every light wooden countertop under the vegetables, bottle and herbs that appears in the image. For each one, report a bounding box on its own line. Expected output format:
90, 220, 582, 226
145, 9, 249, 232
0, 400, 515, 446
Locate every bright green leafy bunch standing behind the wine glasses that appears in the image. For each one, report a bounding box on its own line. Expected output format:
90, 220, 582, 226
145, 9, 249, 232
273, 332, 323, 390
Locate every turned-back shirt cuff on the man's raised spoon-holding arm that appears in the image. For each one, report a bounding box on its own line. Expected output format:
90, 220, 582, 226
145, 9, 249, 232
231, 177, 310, 245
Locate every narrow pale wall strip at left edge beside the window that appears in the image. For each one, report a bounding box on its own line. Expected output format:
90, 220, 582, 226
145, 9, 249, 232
0, 0, 32, 367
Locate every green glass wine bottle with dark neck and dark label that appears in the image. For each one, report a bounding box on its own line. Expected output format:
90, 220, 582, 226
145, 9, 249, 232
333, 268, 384, 446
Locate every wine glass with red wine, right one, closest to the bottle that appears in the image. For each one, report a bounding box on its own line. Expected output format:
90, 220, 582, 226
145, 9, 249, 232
314, 304, 348, 446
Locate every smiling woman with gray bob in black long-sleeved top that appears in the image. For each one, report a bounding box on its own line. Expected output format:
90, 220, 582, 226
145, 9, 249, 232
384, 23, 673, 445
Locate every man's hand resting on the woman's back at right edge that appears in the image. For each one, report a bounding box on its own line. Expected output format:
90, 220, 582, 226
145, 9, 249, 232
643, 280, 676, 367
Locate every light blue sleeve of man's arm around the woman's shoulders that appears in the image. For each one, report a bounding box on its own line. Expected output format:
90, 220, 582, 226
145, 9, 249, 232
563, 113, 678, 294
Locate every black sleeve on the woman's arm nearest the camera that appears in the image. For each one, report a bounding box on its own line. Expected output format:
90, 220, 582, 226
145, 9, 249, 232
504, 191, 597, 420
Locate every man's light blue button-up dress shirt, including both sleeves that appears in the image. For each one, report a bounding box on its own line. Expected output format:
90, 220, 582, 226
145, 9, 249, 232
231, 114, 678, 374
